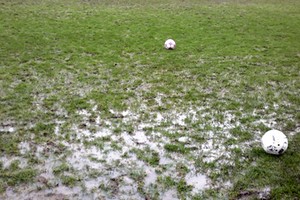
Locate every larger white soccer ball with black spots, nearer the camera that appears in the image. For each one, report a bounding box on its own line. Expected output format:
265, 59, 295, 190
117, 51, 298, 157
261, 130, 288, 155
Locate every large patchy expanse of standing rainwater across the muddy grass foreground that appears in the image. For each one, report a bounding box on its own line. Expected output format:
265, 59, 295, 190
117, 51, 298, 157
0, 104, 278, 200
